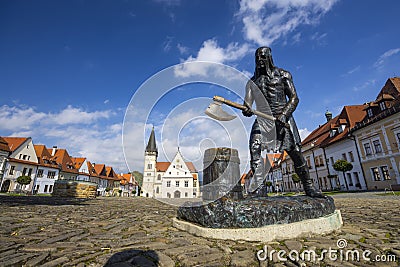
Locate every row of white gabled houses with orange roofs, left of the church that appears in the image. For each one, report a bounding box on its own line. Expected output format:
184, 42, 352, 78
0, 137, 139, 196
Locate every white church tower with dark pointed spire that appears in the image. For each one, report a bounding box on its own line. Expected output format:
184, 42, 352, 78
142, 127, 158, 197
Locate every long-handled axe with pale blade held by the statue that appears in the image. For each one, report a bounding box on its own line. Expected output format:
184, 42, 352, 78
205, 96, 290, 128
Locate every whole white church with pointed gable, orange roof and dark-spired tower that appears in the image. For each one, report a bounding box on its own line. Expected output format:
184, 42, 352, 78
141, 128, 200, 198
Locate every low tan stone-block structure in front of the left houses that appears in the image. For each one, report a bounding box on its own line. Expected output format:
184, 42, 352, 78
52, 180, 97, 198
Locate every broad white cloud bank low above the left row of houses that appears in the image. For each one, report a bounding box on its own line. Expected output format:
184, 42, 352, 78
0, 105, 127, 174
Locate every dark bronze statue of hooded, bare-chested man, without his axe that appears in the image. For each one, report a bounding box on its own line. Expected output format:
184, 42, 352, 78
243, 47, 324, 197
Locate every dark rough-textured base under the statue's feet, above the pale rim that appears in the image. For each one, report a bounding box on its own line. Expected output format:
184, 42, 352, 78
177, 196, 335, 228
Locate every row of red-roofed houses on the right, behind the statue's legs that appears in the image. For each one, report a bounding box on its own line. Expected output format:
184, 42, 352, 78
267, 77, 400, 192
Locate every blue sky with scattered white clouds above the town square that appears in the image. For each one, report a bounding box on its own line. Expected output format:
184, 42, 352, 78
0, 0, 400, 174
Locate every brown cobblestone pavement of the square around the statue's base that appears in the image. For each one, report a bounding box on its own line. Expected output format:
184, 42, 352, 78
0, 193, 400, 267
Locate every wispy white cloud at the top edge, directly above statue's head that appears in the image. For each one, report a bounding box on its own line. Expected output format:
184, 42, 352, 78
238, 0, 337, 46
